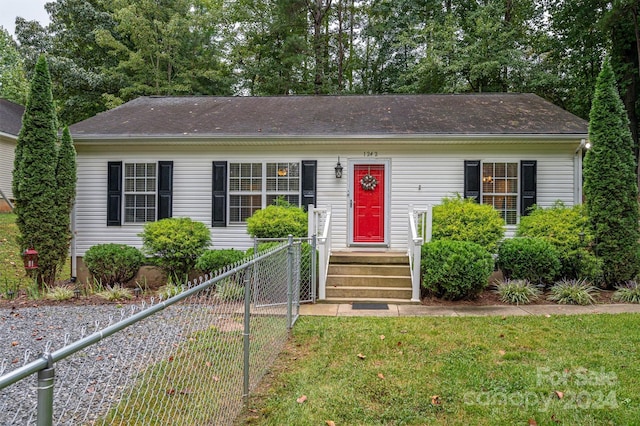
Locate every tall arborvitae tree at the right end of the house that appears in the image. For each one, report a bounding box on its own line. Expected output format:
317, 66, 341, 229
584, 61, 640, 287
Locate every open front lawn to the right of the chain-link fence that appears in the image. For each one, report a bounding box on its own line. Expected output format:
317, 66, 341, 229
238, 314, 640, 425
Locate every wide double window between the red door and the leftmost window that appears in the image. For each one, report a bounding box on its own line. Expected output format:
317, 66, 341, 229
229, 162, 300, 223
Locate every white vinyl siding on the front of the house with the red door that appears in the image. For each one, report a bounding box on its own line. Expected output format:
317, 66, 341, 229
75, 137, 580, 256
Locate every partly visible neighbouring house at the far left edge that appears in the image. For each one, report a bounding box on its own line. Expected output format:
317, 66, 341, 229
0, 99, 24, 211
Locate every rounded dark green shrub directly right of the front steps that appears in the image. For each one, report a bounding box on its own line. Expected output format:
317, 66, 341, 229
421, 240, 493, 300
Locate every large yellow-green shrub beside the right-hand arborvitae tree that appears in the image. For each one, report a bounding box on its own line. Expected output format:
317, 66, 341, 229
516, 201, 601, 279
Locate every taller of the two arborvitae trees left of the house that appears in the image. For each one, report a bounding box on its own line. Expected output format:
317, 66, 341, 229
13, 56, 60, 284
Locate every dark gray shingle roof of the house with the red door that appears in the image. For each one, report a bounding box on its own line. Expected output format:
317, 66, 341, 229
71, 93, 587, 138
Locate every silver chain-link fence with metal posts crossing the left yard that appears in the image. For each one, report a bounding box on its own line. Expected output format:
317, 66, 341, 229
0, 239, 311, 425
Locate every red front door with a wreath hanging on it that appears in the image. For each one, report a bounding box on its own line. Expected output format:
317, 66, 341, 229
353, 164, 385, 243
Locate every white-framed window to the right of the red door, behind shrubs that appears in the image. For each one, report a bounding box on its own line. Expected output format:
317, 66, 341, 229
481, 163, 518, 225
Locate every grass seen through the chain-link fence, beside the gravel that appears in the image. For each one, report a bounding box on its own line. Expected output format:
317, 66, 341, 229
95, 316, 286, 425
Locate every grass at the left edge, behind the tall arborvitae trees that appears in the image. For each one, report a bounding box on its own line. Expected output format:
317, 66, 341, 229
0, 213, 71, 297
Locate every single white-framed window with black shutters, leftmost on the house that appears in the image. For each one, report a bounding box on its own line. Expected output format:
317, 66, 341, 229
124, 163, 157, 223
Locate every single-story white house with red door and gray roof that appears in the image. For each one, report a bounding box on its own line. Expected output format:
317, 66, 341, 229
71, 93, 588, 300
